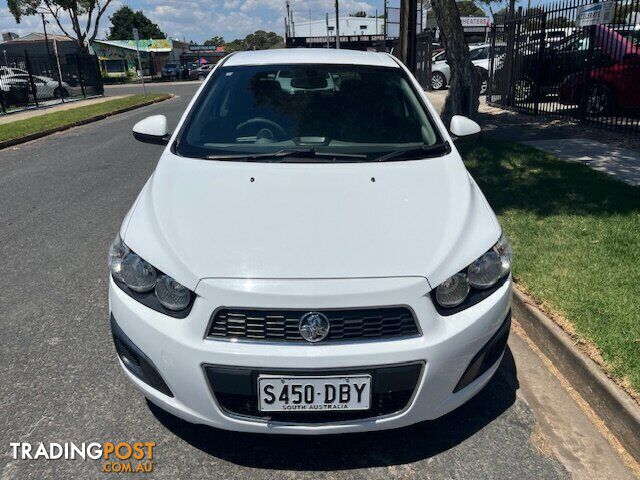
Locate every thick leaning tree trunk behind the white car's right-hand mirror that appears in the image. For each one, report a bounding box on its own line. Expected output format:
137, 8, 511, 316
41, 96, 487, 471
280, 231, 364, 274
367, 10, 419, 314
431, 0, 480, 125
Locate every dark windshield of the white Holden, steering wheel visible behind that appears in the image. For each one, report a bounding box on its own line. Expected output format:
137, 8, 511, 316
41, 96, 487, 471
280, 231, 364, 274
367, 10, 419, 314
175, 64, 445, 161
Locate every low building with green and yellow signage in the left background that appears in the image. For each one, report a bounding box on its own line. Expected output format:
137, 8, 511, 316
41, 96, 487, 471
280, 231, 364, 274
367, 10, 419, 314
91, 38, 189, 78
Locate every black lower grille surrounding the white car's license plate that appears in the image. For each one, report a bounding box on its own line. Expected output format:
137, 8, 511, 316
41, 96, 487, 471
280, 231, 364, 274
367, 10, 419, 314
204, 363, 423, 424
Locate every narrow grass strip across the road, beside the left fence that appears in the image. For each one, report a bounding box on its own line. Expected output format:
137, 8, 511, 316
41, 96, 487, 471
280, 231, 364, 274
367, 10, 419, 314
0, 93, 170, 142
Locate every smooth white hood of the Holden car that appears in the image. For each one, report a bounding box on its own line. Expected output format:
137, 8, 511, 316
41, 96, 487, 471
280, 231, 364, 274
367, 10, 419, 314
121, 149, 500, 289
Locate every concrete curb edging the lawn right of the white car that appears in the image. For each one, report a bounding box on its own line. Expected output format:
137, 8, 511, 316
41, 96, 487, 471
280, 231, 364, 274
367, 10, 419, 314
513, 290, 640, 462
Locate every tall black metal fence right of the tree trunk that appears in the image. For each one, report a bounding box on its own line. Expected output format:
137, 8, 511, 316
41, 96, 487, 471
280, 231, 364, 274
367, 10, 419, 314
487, 0, 640, 131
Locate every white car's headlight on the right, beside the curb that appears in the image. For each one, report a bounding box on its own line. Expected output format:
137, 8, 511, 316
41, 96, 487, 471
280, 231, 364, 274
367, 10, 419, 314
432, 234, 513, 315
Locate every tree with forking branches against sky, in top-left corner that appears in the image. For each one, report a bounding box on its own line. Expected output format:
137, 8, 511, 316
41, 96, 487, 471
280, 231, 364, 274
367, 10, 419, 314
7, 0, 112, 52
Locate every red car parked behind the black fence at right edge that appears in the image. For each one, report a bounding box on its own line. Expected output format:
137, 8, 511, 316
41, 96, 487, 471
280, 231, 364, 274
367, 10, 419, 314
559, 27, 640, 115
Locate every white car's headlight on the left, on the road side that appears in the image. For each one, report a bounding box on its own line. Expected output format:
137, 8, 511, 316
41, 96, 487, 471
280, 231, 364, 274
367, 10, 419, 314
108, 235, 195, 318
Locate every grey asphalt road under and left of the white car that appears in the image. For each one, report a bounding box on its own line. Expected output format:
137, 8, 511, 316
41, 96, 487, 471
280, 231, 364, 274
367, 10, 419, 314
0, 84, 596, 480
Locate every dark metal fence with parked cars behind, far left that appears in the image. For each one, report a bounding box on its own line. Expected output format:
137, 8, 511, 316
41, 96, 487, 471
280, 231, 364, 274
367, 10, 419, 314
0, 51, 104, 113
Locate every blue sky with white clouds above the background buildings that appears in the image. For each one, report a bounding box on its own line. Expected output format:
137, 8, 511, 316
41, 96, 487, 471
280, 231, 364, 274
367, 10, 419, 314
0, 0, 390, 43
